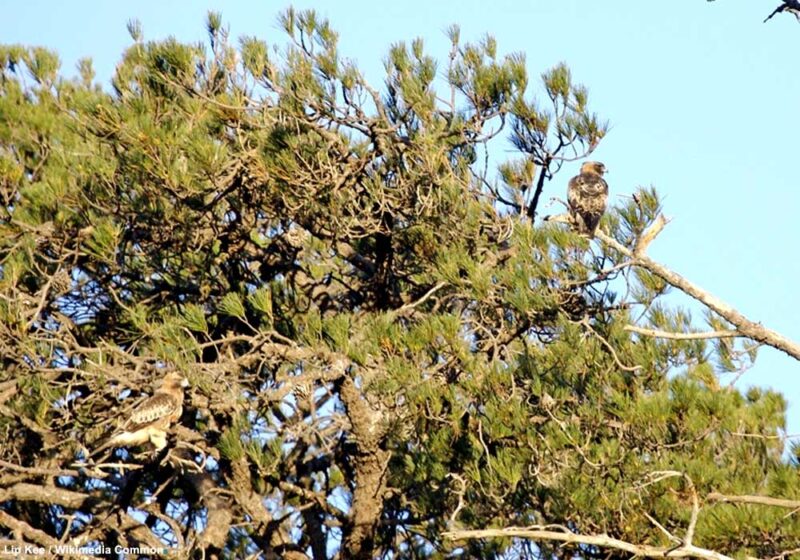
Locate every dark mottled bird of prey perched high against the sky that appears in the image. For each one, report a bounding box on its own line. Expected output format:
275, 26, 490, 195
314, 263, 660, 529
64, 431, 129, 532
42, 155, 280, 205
567, 161, 608, 237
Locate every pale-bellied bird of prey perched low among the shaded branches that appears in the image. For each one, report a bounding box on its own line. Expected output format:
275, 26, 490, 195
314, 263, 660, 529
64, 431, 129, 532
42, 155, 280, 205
92, 371, 189, 455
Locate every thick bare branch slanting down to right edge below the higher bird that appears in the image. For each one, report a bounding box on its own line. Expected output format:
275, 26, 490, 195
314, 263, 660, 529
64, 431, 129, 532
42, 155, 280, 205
596, 231, 800, 360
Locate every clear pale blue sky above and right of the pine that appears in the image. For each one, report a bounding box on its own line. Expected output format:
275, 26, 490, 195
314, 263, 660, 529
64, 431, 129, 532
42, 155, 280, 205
0, 0, 800, 433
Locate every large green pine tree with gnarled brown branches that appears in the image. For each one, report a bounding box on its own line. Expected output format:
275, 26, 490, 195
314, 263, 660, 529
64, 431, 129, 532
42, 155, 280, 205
0, 9, 800, 560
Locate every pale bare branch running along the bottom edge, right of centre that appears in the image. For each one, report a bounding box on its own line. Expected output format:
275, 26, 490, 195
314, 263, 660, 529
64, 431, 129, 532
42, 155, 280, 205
442, 527, 733, 560
